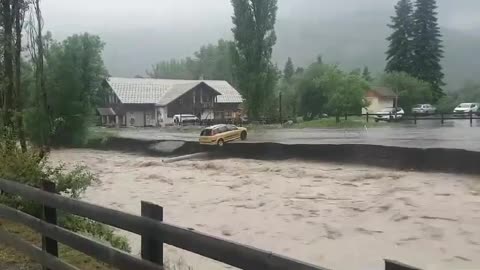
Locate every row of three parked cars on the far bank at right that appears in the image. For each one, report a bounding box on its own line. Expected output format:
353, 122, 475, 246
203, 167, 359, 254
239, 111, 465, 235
375, 103, 480, 122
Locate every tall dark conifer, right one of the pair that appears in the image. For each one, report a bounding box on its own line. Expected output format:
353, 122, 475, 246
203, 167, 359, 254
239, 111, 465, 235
412, 0, 445, 101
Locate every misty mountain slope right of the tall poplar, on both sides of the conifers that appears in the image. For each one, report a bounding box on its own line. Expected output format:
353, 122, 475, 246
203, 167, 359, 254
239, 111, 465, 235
274, 13, 480, 89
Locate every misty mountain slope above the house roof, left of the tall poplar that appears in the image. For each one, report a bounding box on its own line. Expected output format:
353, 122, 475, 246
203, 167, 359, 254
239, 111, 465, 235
99, 25, 230, 77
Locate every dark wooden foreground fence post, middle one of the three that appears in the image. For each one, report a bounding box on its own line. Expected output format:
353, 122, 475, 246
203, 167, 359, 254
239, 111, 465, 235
141, 201, 163, 266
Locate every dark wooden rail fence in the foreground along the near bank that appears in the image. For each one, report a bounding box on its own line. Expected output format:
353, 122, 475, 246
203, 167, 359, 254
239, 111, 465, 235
0, 179, 417, 270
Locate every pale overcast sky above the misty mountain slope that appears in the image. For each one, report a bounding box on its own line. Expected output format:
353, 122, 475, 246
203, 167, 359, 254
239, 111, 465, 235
42, 0, 480, 34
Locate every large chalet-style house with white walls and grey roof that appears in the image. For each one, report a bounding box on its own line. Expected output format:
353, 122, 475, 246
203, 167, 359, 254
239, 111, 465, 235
97, 77, 243, 127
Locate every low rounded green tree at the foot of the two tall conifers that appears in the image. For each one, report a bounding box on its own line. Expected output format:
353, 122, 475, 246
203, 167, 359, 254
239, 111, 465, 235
380, 72, 432, 111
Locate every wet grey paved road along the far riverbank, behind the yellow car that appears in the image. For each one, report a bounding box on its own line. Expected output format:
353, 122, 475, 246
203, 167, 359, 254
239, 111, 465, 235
115, 120, 480, 151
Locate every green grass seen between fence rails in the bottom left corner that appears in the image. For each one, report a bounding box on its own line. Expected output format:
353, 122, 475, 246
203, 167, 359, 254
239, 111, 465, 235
0, 219, 114, 270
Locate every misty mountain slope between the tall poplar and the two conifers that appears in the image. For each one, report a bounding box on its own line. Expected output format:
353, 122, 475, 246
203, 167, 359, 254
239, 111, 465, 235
274, 12, 389, 71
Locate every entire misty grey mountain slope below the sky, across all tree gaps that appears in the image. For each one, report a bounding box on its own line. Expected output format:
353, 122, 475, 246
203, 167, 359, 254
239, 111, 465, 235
99, 6, 480, 89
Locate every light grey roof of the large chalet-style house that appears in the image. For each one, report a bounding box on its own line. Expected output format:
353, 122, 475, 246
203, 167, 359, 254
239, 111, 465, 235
107, 77, 243, 105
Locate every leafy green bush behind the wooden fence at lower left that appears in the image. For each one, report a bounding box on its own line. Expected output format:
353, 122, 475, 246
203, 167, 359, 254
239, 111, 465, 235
0, 135, 130, 251
